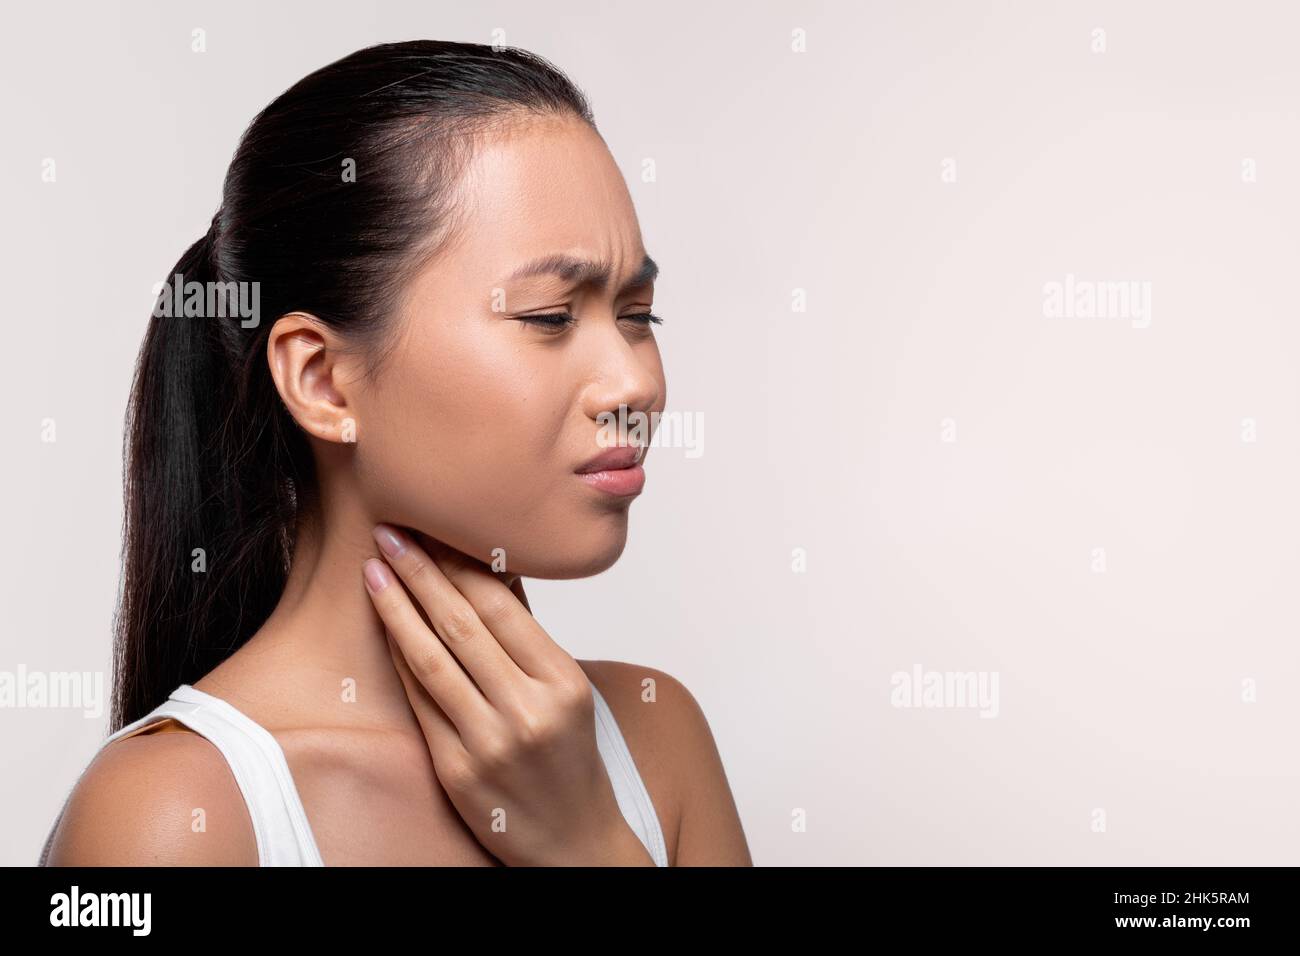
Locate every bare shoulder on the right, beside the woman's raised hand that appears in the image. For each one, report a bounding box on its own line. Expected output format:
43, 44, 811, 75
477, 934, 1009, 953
579, 661, 751, 866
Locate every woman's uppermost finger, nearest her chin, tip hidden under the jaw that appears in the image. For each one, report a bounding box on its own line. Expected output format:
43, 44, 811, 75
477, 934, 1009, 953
416, 533, 572, 680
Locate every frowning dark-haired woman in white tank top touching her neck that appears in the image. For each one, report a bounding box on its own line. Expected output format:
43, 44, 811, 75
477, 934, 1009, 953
42, 42, 751, 865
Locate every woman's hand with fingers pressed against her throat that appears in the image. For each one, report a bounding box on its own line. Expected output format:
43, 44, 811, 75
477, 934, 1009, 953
364, 524, 654, 866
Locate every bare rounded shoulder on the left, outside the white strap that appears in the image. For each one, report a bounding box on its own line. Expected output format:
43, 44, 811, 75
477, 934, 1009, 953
47, 732, 257, 866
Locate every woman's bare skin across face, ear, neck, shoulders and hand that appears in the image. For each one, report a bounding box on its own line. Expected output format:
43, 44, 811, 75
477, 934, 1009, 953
49, 111, 751, 866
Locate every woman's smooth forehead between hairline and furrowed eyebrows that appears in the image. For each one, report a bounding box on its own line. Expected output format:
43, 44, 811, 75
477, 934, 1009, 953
441, 117, 642, 281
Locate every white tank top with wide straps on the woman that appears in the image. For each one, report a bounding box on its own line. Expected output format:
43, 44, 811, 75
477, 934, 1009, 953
40, 682, 668, 866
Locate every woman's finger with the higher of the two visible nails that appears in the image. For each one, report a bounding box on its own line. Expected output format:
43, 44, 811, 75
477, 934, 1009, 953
374, 524, 525, 702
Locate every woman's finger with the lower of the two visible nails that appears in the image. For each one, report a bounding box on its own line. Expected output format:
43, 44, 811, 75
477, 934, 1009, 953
363, 558, 491, 731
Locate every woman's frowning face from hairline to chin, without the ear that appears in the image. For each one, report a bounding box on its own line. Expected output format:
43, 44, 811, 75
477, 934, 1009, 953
355, 111, 666, 578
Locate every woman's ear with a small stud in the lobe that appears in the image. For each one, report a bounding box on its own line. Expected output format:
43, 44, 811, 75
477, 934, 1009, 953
267, 312, 358, 442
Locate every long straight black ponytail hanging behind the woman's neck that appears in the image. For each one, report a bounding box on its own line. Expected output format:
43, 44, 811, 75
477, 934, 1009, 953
111, 213, 296, 731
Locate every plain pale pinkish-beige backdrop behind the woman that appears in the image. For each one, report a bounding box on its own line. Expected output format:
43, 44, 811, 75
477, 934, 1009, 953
0, 1, 1300, 865
